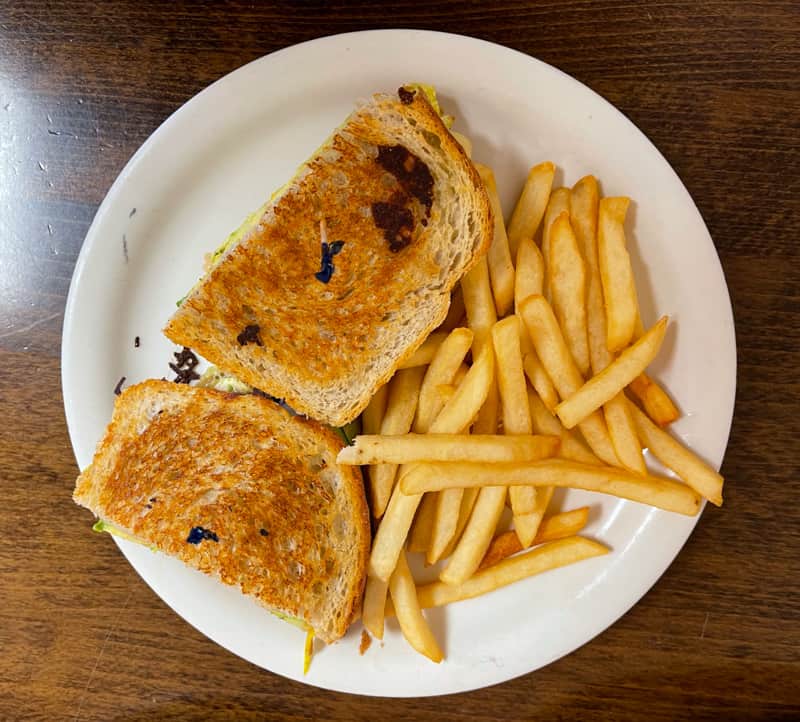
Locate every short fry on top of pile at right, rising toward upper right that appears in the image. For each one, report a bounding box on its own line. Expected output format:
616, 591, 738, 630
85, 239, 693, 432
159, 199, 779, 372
552, 316, 669, 429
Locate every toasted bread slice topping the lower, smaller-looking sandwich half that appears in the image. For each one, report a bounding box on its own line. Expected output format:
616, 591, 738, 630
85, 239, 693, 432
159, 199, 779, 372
74, 381, 370, 642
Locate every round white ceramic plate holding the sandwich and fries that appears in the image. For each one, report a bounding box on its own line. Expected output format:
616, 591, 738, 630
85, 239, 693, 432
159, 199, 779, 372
62, 30, 736, 696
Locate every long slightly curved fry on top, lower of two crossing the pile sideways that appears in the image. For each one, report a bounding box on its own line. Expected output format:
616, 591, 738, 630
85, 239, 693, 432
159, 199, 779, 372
399, 459, 700, 516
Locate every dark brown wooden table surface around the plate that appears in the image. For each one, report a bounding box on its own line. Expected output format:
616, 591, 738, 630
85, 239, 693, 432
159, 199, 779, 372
0, 0, 800, 720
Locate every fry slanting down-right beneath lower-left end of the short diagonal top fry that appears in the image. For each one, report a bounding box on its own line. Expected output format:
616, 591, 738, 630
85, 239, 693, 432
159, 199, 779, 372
521, 296, 619, 466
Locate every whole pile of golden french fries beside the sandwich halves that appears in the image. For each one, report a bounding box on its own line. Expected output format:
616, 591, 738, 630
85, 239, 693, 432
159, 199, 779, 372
338, 156, 723, 662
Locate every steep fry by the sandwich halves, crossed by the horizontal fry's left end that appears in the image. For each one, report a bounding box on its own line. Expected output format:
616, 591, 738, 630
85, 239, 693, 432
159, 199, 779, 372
369, 366, 425, 519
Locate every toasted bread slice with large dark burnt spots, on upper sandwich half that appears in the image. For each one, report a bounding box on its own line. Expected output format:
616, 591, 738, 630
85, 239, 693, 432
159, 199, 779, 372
164, 88, 492, 426
